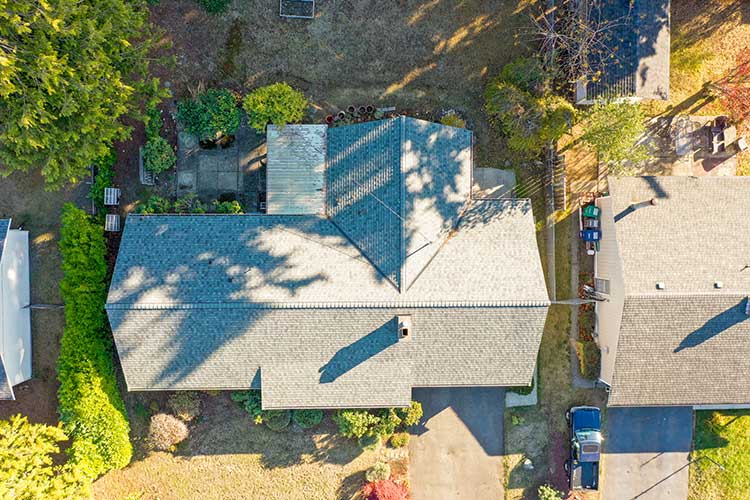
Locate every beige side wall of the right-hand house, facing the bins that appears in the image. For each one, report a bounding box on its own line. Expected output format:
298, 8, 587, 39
594, 196, 625, 385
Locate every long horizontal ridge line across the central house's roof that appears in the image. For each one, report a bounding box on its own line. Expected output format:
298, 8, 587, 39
105, 300, 550, 310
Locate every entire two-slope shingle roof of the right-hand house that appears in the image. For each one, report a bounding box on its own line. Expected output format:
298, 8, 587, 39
609, 177, 750, 406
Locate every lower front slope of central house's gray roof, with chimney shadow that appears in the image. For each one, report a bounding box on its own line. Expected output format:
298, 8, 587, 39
108, 306, 547, 408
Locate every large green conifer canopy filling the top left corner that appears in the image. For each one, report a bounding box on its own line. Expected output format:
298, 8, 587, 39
0, 0, 158, 189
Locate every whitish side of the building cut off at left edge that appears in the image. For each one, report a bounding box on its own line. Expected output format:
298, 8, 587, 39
0, 230, 31, 385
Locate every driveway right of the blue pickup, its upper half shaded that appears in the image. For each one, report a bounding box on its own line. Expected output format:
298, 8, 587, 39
601, 407, 693, 500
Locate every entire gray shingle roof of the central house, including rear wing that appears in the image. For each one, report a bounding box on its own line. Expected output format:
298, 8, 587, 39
107, 118, 549, 408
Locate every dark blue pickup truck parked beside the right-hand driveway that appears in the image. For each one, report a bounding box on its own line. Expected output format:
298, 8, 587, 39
565, 406, 602, 490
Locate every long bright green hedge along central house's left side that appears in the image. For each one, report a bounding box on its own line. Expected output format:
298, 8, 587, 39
57, 203, 133, 478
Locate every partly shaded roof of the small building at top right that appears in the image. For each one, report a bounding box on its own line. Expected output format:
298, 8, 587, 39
579, 0, 670, 102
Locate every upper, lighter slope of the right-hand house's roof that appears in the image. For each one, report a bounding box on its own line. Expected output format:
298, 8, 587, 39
609, 177, 750, 295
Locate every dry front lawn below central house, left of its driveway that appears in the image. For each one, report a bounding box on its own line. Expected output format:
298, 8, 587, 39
93, 392, 379, 500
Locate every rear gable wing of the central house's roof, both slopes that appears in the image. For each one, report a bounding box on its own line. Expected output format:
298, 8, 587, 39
326, 117, 472, 292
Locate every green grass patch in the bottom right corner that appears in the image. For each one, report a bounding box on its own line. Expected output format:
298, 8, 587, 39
689, 410, 750, 500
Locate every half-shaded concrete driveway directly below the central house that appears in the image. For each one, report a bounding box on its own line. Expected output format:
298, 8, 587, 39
409, 387, 505, 500
